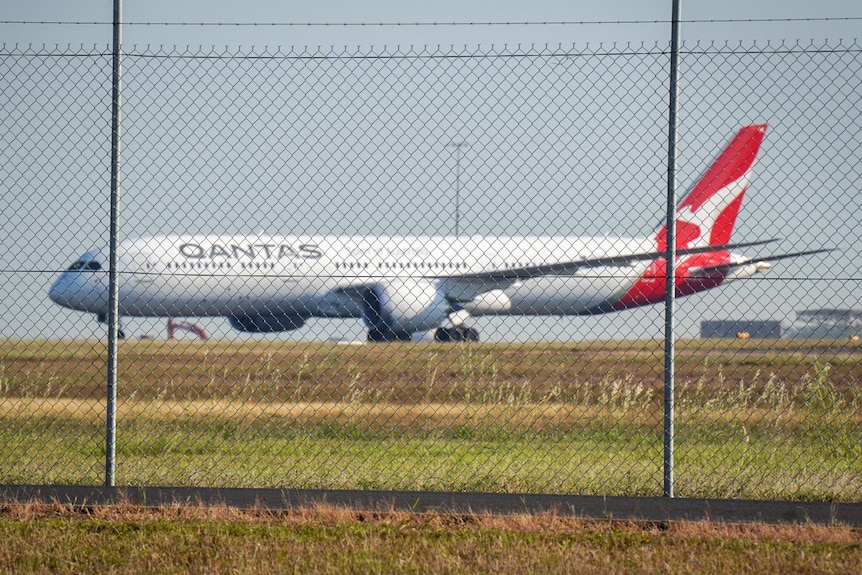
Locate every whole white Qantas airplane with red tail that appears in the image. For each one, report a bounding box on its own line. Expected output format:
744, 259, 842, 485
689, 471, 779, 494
49, 124, 828, 341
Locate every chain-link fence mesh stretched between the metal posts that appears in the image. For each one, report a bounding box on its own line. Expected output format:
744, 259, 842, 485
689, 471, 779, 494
0, 42, 862, 501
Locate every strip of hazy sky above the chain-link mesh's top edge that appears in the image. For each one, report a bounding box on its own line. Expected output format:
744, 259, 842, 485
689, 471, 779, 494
0, 0, 862, 47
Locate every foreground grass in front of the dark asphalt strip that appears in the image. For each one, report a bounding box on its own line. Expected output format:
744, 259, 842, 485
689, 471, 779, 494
0, 503, 862, 574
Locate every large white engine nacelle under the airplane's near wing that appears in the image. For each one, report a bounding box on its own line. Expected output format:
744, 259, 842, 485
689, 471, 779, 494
362, 278, 451, 339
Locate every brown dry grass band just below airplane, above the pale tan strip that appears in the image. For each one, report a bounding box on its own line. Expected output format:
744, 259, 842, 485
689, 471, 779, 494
6, 340, 862, 403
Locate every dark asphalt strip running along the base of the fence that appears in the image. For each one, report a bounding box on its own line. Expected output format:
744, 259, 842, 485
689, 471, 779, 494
0, 485, 862, 527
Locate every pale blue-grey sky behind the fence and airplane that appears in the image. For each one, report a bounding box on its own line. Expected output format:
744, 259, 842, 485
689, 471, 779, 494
0, 0, 862, 339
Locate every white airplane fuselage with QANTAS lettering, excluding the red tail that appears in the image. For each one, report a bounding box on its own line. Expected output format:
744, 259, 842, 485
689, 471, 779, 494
51, 236, 650, 317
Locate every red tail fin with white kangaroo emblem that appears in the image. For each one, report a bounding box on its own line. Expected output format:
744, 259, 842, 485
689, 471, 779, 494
655, 124, 766, 251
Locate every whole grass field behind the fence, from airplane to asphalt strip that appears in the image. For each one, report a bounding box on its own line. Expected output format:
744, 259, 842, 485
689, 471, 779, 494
0, 340, 862, 501
